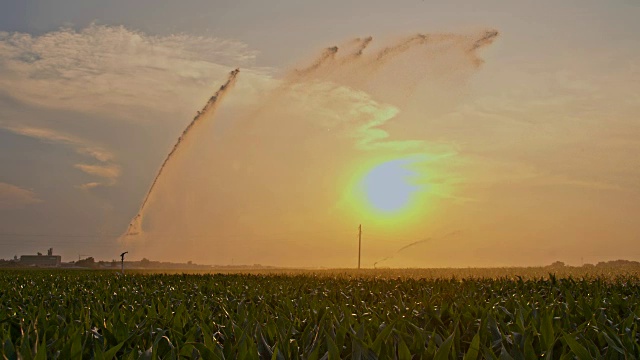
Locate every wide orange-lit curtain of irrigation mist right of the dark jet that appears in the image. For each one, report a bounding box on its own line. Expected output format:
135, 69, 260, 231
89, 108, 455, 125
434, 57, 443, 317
123, 30, 497, 266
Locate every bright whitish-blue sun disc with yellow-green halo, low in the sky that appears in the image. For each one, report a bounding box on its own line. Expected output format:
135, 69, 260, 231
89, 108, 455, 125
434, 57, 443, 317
362, 160, 419, 213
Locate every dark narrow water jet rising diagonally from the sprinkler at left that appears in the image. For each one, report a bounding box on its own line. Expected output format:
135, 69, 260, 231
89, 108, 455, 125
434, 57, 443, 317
125, 69, 240, 236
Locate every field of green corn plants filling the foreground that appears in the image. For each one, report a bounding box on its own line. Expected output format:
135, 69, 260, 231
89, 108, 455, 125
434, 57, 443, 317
0, 270, 640, 359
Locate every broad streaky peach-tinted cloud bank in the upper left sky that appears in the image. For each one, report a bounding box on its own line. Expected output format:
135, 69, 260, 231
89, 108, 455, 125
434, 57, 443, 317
0, 25, 255, 118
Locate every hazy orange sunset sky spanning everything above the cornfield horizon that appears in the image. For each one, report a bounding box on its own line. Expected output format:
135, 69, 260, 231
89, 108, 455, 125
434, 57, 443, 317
0, 0, 640, 267
